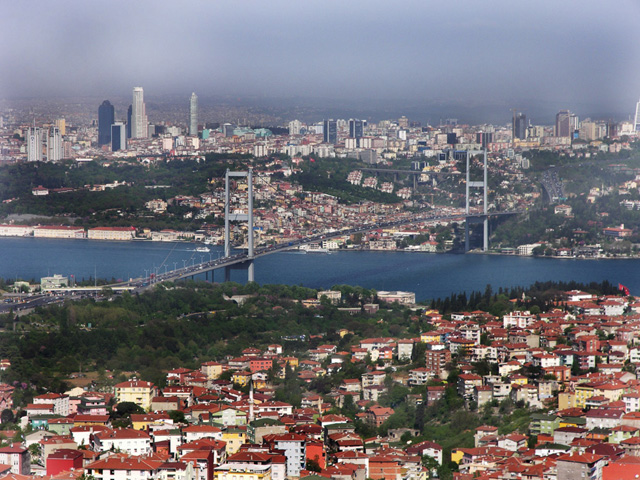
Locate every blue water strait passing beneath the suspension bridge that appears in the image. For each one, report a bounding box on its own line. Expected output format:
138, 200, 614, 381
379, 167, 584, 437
0, 238, 640, 301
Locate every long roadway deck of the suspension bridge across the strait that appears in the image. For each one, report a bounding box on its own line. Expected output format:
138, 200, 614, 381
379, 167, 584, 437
121, 211, 519, 291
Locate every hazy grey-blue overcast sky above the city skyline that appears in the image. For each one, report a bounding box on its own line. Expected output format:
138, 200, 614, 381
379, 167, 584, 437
0, 0, 640, 118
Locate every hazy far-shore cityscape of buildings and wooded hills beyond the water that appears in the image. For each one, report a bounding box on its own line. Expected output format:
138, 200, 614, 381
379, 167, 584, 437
5, 102, 640, 258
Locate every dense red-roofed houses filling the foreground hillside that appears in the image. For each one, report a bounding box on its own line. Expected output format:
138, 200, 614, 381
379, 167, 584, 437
0, 284, 640, 480
